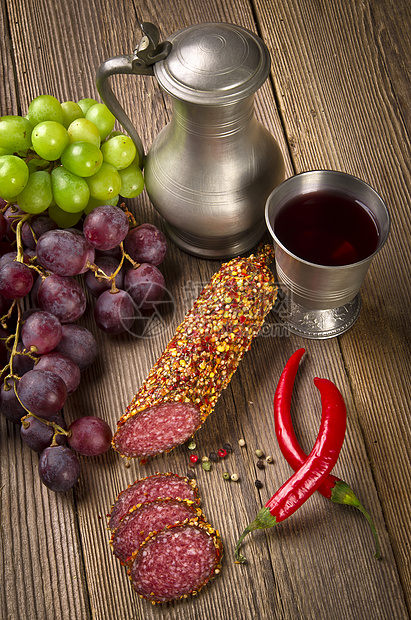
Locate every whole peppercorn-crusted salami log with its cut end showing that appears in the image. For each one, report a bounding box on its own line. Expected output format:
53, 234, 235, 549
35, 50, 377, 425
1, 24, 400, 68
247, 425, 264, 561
113, 246, 277, 458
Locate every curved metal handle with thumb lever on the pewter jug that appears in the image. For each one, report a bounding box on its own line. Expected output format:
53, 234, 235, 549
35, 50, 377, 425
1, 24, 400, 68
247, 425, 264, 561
96, 22, 171, 167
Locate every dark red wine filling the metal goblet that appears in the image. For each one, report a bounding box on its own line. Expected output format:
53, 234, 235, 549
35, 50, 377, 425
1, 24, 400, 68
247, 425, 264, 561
274, 190, 379, 266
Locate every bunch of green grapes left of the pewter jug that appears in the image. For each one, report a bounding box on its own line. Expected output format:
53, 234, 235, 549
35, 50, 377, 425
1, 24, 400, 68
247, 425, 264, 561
0, 95, 144, 228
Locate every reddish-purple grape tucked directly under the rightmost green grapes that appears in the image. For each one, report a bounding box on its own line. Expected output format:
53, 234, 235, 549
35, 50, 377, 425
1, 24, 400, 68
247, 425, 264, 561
83, 205, 129, 250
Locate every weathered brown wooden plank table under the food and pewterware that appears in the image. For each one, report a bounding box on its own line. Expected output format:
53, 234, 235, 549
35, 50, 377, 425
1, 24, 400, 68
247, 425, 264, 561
0, 0, 411, 620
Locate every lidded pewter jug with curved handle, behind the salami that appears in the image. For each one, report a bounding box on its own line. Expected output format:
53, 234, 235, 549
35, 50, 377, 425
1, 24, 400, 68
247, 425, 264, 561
97, 22, 285, 259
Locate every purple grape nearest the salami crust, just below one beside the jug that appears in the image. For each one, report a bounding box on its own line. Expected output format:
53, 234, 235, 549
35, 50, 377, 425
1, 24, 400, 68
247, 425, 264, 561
124, 263, 165, 310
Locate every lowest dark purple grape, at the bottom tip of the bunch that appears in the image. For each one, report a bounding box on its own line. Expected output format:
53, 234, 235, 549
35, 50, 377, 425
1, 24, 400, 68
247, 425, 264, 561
39, 446, 80, 493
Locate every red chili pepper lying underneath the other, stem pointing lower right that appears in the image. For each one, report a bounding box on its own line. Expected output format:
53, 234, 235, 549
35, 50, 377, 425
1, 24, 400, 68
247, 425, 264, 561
274, 349, 381, 559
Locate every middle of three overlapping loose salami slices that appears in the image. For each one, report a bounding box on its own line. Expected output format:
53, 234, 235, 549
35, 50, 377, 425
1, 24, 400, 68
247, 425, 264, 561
110, 499, 202, 564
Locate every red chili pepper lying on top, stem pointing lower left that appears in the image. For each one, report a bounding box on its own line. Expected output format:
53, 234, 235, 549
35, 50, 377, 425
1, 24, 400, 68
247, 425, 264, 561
235, 377, 347, 563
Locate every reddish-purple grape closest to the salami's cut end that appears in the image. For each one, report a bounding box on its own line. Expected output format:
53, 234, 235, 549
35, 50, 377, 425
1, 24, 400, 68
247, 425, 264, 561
67, 415, 113, 456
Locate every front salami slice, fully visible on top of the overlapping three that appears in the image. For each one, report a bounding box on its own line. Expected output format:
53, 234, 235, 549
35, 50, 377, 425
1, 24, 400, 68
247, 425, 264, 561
128, 519, 222, 603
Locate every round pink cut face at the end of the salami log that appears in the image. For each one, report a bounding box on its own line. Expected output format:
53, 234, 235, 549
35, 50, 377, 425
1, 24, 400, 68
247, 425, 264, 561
113, 402, 201, 458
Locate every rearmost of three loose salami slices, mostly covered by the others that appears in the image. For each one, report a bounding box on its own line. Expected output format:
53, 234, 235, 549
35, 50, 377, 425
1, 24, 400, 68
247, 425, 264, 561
108, 472, 200, 530
